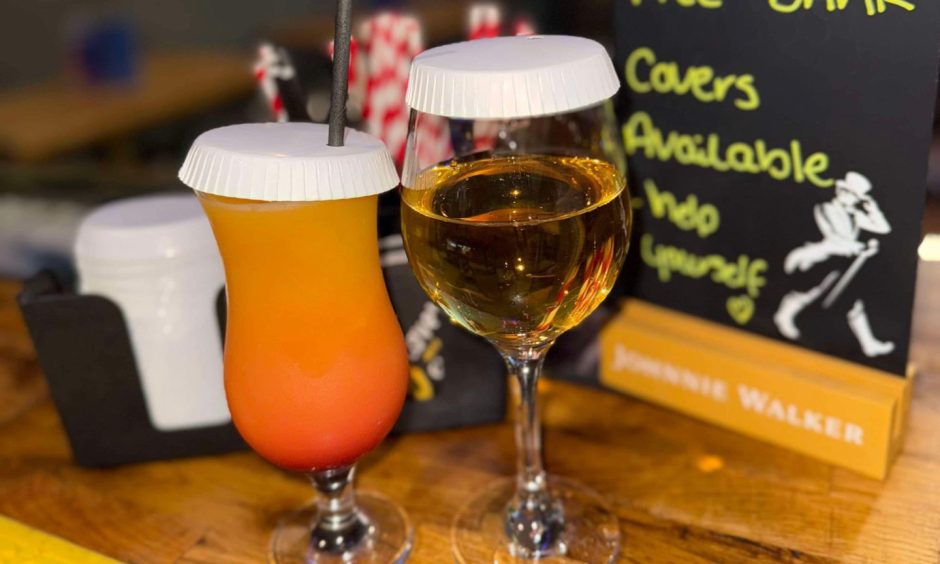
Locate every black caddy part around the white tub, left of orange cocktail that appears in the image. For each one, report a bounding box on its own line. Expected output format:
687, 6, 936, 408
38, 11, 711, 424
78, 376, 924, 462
17, 271, 246, 467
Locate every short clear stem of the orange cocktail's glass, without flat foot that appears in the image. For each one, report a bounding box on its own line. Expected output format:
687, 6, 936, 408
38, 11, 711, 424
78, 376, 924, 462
309, 465, 372, 555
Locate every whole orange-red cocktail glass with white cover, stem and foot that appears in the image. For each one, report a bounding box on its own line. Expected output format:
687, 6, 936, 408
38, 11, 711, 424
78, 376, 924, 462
179, 123, 413, 564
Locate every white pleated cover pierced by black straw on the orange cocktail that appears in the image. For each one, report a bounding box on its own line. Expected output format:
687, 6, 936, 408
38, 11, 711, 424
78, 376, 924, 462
179, 123, 398, 202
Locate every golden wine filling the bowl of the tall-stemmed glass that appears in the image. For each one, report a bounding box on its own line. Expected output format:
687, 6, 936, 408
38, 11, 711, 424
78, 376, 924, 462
402, 145, 630, 349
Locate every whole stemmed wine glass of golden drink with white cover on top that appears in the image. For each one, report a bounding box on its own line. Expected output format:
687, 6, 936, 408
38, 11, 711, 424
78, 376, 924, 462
402, 36, 632, 562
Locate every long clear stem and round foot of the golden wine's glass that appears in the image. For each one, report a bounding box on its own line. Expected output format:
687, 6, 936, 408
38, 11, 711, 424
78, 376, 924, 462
453, 346, 620, 563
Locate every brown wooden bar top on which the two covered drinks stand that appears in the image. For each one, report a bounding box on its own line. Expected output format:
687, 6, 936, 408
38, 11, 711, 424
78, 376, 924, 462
0, 263, 940, 563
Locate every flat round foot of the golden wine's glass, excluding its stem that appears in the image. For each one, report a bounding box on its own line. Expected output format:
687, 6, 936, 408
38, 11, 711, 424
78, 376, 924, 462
451, 477, 620, 564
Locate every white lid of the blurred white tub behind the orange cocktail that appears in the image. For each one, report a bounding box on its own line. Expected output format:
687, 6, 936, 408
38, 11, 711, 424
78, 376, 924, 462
75, 194, 219, 268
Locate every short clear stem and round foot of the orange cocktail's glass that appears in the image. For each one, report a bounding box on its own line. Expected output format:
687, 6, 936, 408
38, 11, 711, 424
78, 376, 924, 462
270, 466, 412, 564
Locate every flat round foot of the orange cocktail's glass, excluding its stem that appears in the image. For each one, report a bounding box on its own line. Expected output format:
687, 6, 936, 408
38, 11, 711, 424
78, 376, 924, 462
268, 492, 414, 564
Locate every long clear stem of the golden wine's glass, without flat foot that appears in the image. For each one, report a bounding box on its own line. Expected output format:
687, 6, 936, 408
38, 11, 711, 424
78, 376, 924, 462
503, 347, 565, 558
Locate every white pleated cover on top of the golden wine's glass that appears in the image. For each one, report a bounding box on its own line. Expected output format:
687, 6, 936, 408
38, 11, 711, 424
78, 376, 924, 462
405, 35, 620, 119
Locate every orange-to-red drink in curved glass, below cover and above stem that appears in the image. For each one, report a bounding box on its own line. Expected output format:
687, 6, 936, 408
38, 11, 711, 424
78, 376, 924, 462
197, 192, 408, 471
